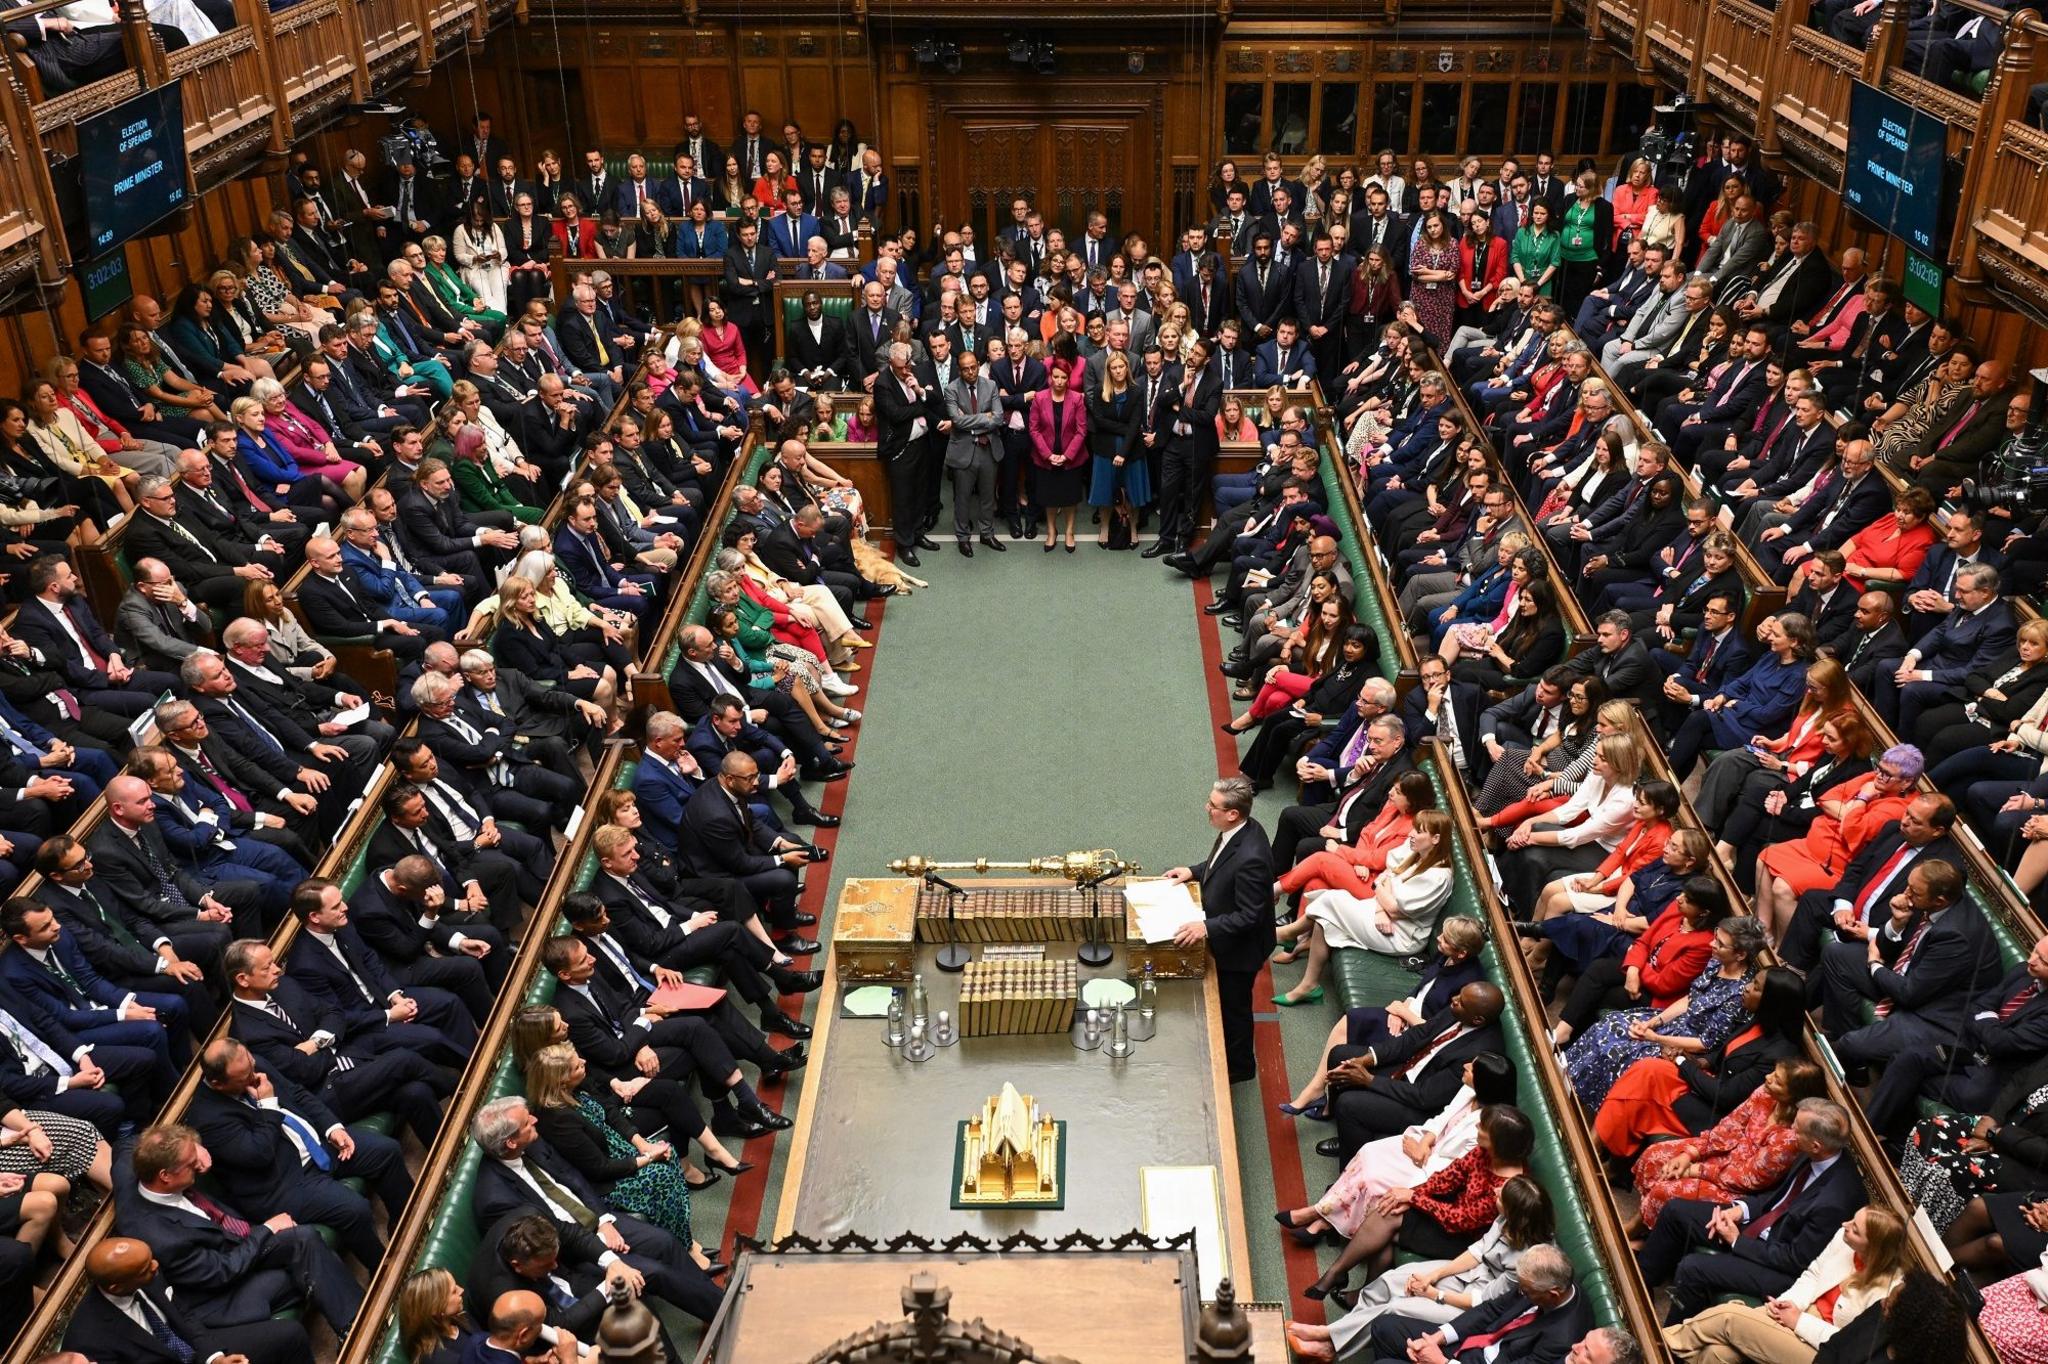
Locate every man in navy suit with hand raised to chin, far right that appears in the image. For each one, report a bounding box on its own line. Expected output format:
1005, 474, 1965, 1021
1819, 860, 1999, 1083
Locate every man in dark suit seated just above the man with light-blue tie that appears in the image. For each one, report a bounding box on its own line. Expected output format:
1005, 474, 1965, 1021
223, 938, 455, 1147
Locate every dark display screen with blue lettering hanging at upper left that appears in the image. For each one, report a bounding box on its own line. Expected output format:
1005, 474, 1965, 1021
78, 82, 193, 258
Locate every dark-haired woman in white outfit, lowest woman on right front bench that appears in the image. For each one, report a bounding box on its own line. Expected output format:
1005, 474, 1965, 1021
1286, 1176, 1556, 1360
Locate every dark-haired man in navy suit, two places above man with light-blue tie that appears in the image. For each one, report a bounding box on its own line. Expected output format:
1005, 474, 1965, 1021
285, 877, 477, 1065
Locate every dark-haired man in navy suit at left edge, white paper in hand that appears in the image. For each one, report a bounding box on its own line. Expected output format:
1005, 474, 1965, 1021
0, 897, 193, 1069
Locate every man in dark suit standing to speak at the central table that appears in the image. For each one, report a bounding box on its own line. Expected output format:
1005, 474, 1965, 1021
1165, 776, 1274, 1083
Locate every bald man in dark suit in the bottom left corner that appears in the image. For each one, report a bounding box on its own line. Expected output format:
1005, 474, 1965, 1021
63, 1237, 311, 1364
